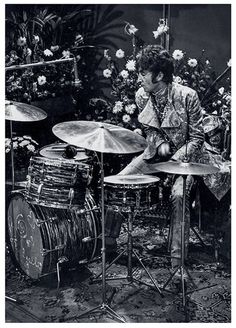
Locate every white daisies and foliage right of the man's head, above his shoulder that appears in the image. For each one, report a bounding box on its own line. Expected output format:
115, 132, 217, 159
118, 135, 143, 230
172, 49, 231, 124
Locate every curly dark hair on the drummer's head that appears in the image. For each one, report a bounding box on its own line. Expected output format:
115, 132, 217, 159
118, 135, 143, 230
136, 45, 174, 83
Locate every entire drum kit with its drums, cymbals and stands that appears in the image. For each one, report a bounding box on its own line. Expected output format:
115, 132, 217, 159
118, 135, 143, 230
5, 101, 218, 322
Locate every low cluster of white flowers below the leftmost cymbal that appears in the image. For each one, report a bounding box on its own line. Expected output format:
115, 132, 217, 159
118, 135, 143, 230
5, 136, 38, 169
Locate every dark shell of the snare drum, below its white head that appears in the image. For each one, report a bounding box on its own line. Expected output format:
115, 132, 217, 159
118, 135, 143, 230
104, 182, 159, 210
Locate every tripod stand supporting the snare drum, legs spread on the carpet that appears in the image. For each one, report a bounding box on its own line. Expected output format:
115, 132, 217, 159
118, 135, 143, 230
92, 210, 164, 297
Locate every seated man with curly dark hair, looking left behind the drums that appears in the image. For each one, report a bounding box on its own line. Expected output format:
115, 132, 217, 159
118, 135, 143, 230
107, 45, 204, 277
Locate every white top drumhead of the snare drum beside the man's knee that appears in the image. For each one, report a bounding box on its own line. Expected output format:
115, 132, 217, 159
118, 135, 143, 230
104, 174, 160, 185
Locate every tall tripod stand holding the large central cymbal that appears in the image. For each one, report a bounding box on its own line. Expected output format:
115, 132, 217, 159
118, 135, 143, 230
76, 153, 125, 322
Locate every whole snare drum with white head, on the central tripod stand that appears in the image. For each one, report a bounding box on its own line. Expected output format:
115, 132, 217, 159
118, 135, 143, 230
104, 175, 160, 212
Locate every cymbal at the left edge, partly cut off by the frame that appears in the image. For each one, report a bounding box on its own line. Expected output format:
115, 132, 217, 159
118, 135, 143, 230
5, 100, 47, 122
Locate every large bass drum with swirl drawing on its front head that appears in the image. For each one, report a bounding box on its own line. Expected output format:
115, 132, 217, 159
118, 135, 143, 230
7, 191, 101, 279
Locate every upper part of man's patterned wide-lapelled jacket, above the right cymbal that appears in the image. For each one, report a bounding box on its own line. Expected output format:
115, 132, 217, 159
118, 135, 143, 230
136, 83, 204, 161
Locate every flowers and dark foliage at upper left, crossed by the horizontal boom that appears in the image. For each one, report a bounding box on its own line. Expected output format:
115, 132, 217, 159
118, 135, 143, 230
5, 25, 83, 102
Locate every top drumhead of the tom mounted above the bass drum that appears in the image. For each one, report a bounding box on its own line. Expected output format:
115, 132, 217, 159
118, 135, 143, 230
39, 143, 89, 161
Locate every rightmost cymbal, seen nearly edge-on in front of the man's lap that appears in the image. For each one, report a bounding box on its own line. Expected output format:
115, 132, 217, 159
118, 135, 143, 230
152, 161, 219, 175
